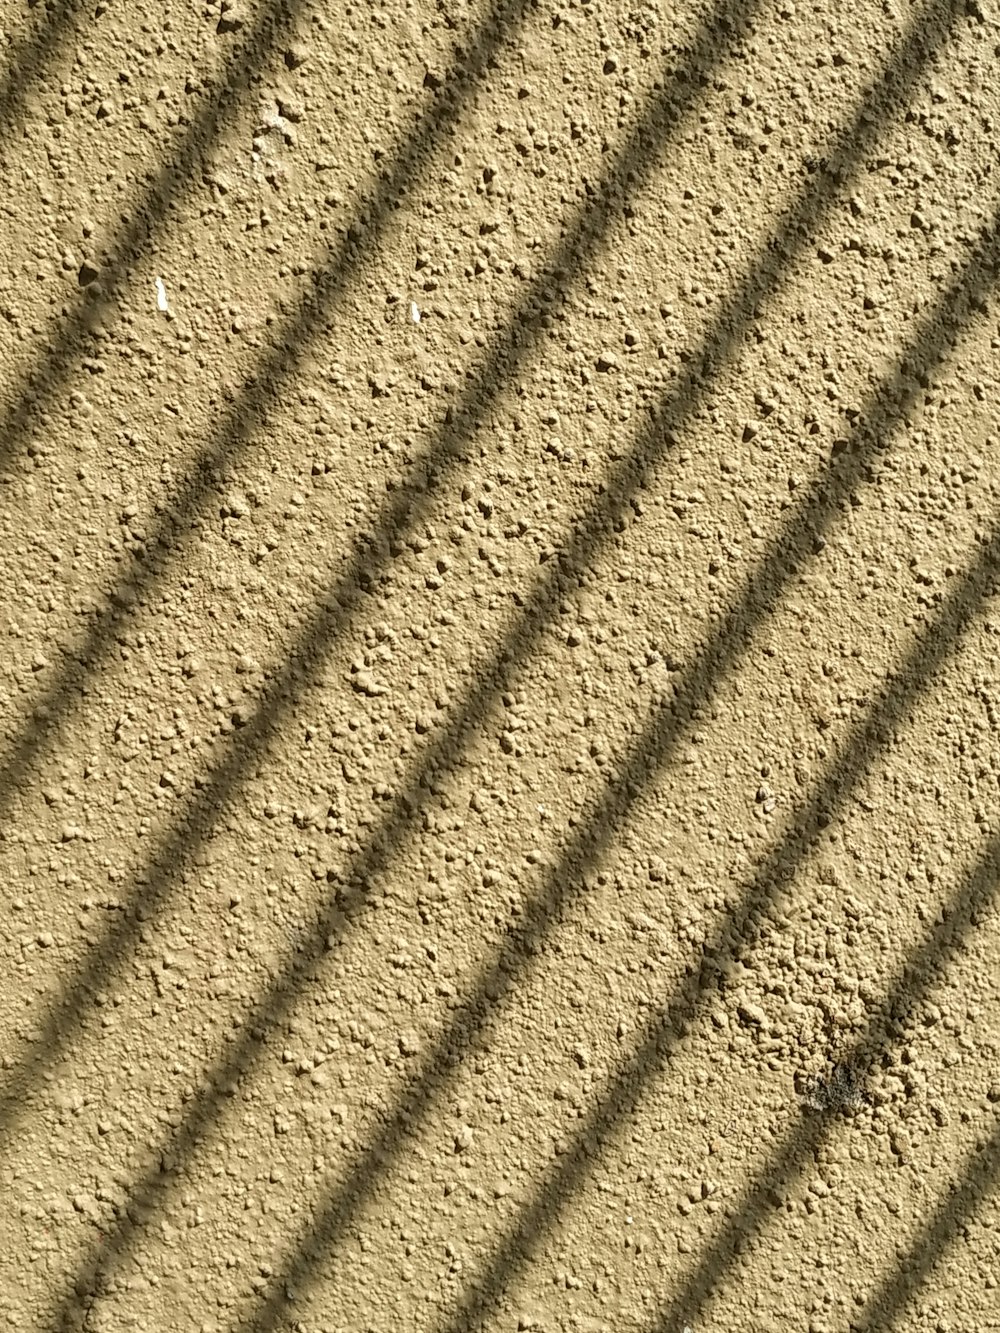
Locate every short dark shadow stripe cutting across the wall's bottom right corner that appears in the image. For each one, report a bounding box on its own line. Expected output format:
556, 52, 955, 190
848, 1109, 1000, 1333
